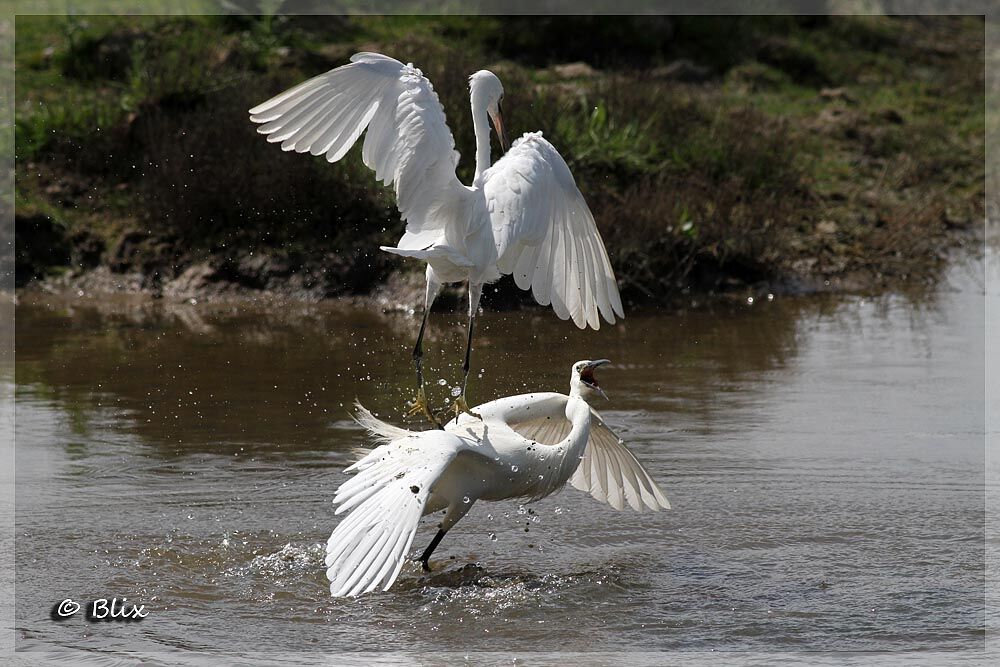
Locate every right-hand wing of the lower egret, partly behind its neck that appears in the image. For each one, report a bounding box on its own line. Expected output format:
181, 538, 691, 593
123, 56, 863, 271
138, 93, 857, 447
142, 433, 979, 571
510, 410, 670, 512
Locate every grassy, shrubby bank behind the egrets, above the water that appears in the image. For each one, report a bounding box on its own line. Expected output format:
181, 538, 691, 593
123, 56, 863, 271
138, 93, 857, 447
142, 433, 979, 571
15, 16, 984, 302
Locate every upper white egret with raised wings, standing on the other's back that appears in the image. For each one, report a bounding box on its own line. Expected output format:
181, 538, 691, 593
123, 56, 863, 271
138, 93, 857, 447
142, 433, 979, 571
250, 53, 624, 421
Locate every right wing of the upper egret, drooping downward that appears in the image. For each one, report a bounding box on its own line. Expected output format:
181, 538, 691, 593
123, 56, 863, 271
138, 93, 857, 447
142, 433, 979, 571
483, 132, 624, 329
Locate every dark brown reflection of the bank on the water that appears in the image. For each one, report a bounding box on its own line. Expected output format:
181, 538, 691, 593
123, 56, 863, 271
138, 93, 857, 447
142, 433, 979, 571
16, 290, 812, 454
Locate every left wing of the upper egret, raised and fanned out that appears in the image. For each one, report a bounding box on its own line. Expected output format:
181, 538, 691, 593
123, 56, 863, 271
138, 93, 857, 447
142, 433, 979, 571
250, 53, 468, 233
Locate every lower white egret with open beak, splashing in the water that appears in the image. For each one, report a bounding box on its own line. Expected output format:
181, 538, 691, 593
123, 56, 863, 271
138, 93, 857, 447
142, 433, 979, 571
326, 359, 670, 597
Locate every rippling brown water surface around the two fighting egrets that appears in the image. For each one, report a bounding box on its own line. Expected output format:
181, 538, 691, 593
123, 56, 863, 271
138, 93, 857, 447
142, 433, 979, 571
8, 254, 984, 664
